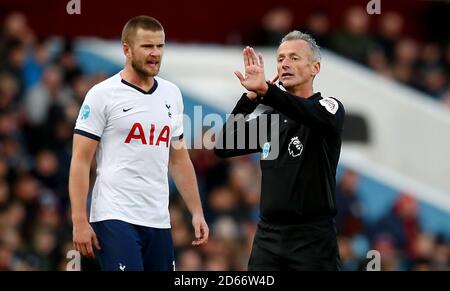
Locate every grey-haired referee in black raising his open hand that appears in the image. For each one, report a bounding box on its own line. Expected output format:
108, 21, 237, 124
214, 31, 345, 271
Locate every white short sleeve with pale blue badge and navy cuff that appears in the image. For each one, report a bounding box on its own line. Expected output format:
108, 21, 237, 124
74, 87, 106, 141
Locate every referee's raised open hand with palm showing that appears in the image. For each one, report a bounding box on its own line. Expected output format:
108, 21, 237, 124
234, 47, 268, 95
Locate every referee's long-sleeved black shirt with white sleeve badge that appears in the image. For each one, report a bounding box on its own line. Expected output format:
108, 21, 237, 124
214, 85, 345, 224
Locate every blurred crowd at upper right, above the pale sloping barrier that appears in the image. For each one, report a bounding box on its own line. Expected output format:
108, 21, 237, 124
248, 6, 450, 106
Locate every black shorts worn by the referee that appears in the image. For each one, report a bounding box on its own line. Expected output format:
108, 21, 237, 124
248, 218, 341, 271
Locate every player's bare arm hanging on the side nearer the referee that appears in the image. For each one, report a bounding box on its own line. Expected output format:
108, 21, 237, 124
169, 139, 209, 246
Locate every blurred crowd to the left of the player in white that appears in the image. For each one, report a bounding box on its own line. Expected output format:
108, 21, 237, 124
0, 13, 105, 270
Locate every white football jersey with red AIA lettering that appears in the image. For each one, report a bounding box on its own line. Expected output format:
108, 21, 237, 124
75, 73, 183, 228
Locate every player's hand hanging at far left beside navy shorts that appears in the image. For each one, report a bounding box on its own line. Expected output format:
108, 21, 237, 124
73, 221, 100, 258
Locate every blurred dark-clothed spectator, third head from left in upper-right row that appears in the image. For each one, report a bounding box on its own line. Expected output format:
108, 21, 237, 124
331, 7, 373, 64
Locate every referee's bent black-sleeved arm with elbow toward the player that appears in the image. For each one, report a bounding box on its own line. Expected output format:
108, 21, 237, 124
214, 94, 261, 158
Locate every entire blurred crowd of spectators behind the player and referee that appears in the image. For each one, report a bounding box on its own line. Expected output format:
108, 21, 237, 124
0, 9, 450, 270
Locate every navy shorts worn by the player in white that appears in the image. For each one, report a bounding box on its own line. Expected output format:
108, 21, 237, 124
92, 220, 175, 271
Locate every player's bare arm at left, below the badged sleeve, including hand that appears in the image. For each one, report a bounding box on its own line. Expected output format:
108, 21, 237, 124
69, 134, 100, 257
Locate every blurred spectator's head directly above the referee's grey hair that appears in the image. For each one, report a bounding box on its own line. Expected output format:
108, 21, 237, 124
255, 6, 294, 46
